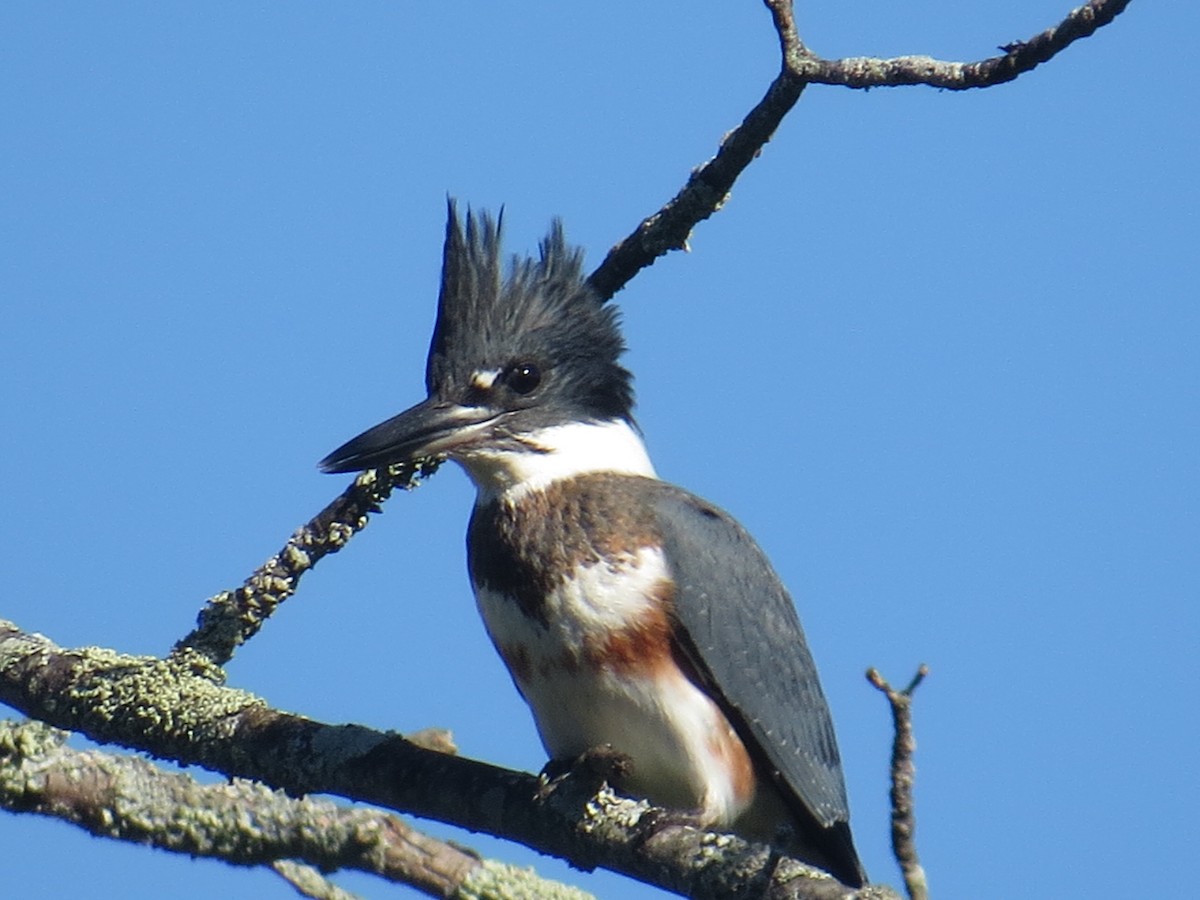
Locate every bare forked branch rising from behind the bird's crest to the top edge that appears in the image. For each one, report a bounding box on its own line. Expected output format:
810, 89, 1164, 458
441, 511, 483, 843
588, 0, 1129, 300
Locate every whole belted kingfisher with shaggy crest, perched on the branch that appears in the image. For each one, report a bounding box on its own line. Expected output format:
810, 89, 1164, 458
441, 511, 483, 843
320, 202, 865, 887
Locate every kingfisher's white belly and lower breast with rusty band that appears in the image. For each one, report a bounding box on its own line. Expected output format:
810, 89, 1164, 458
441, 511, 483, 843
476, 547, 754, 824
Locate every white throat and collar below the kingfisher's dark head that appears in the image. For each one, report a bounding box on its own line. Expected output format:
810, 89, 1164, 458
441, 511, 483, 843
456, 419, 658, 503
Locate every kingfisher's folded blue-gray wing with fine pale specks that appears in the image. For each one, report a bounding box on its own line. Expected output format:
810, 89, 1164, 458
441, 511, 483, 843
654, 482, 848, 828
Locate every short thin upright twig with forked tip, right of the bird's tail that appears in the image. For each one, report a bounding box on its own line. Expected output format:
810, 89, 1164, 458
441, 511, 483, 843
866, 664, 929, 900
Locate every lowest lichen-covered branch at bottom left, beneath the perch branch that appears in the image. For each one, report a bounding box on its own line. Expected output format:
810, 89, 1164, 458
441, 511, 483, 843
0, 720, 501, 896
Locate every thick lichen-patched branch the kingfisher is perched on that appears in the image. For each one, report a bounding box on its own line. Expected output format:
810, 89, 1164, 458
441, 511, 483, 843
0, 622, 895, 900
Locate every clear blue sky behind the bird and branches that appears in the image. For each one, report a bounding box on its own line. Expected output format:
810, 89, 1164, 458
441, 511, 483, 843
0, 0, 1200, 899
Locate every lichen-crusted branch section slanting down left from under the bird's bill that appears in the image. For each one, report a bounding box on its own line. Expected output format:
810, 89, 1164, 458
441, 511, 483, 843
172, 461, 437, 666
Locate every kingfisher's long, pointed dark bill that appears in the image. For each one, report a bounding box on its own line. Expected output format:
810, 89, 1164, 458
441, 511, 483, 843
318, 397, 499, 473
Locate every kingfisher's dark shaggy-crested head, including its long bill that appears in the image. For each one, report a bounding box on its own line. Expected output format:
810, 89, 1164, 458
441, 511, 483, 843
320, 202, 634, 494
